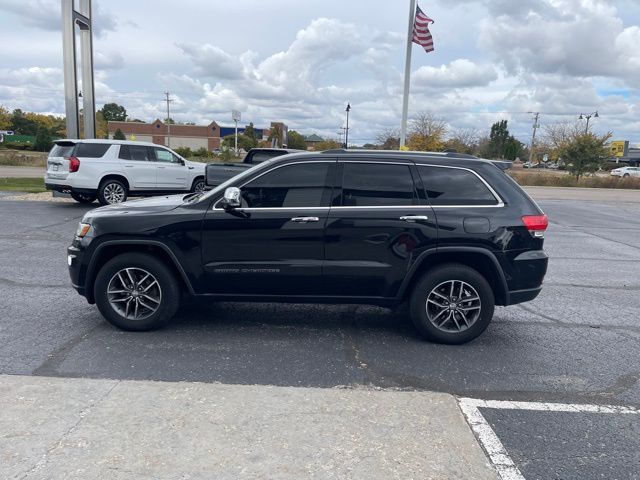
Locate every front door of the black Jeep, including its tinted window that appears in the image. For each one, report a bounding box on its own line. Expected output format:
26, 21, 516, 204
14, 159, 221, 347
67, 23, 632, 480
202, 160, 336, 296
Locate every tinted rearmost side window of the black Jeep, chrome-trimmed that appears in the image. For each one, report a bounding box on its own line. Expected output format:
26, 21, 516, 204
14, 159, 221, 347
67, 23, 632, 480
418, 167, 498, 205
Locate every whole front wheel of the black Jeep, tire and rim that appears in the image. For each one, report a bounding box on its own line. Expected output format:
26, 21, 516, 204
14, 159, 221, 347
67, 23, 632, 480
94, 253, 180, 331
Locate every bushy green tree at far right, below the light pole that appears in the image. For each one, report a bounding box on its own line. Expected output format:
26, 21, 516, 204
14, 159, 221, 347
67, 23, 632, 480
559, 132, 611, 181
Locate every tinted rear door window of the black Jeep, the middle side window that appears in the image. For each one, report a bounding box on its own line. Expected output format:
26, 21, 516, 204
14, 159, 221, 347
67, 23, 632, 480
342, 163, 416, 207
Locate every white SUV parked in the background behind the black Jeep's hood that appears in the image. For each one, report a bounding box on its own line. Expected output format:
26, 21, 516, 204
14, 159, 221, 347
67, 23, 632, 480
44, 140, 205, 205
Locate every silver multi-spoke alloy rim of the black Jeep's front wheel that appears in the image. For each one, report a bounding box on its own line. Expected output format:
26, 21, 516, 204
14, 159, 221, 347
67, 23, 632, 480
107, 267, 162, 320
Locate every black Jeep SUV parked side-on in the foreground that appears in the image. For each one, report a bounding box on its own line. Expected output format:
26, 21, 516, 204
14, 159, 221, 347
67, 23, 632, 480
68, 151, 548, 343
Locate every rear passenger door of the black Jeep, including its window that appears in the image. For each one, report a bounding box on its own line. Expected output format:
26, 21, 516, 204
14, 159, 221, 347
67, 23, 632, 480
324, 161, 437, 297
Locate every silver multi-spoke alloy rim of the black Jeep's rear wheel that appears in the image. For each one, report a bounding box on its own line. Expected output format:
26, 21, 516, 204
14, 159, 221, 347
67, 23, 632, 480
426, 280, 482, 333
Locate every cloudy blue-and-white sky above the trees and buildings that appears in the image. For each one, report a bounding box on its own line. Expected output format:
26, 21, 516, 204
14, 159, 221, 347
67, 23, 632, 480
0, 0, 640, 144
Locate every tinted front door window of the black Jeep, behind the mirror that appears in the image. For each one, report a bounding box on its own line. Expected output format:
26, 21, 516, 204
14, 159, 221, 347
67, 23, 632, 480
242, 163, 331, 208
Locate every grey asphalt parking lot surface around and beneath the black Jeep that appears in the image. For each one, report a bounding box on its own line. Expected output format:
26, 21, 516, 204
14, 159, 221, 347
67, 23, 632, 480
0, 192, 640, 479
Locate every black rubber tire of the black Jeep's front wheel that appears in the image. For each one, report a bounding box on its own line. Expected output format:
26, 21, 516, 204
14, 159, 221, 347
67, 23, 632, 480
94, 253, 181, 332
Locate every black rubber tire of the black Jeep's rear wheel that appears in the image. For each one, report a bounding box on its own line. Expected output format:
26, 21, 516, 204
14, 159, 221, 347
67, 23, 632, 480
409, 263, 495, 345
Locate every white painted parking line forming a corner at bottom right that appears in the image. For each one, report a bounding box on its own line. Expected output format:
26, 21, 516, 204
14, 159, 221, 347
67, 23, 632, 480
459, 398, 640, 480
